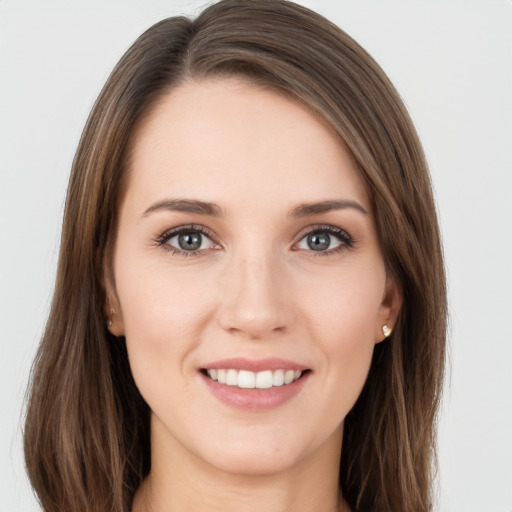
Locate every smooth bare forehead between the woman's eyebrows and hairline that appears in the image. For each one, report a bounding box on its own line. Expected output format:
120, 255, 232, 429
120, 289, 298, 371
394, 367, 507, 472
127, 78, 369, 216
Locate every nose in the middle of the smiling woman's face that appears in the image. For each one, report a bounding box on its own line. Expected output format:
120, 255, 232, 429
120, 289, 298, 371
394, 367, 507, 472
218, 251, 294, 340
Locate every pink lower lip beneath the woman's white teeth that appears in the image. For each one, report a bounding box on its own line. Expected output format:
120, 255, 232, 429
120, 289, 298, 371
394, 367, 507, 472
200, 372, 310, 411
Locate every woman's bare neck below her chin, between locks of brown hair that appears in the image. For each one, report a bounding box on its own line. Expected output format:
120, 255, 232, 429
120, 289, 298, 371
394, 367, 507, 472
132, 416, 348, 512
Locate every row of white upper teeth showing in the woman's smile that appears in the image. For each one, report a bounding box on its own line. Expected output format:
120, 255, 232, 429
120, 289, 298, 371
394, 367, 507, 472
206, 369, 302, 389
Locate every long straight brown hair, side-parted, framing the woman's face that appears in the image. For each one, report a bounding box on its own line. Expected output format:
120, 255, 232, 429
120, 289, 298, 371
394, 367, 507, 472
25, 0, 446, 512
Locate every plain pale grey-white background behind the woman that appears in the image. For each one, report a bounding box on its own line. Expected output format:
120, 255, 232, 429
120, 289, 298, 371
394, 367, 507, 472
0, 0, 512, 512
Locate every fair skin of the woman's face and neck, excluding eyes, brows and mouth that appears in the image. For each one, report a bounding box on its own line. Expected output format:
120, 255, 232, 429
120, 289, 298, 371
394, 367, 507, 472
106, 79, 401, 512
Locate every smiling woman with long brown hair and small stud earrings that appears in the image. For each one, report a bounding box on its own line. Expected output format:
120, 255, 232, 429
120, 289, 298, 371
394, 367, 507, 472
25, 0, 446, 512
